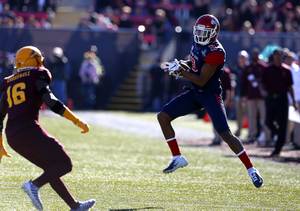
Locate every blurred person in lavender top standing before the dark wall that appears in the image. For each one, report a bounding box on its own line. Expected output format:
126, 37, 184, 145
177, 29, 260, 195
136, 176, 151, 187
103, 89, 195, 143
79, 49, 104, 109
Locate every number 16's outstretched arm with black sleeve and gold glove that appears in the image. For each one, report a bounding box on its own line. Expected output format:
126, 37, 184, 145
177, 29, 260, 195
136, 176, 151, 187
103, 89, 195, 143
36, 80, 89, 133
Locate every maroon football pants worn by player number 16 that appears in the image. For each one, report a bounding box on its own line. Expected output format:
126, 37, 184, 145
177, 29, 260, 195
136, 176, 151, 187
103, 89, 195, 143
7, 124, 77, 208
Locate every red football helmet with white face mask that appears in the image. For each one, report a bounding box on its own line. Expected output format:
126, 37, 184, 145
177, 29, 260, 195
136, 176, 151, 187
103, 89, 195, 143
193, 15, 220, 45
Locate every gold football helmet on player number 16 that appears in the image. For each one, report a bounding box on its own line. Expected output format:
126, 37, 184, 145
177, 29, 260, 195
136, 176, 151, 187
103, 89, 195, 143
15, 46, 44, 69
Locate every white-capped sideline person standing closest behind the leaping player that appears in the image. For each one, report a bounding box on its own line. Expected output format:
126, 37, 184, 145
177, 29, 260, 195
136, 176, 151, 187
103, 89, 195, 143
232, 50, 249, 136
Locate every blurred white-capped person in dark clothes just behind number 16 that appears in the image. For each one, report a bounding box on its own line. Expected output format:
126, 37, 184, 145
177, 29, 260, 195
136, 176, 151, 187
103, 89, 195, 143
47, 47, 71, 104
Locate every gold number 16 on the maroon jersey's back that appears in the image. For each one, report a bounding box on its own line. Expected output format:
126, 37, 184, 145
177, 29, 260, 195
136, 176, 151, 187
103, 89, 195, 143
6, 82, 26, 108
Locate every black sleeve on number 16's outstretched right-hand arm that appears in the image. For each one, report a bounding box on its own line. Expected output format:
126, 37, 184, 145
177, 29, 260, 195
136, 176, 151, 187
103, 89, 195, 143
36, 79, 65, 116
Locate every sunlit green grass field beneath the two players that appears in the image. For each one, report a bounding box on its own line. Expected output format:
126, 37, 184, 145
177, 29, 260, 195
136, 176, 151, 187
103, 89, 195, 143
0, 113, 300, 211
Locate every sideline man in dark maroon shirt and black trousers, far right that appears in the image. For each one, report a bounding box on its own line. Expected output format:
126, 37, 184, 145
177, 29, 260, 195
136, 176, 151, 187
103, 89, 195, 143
262, 50, 297, 157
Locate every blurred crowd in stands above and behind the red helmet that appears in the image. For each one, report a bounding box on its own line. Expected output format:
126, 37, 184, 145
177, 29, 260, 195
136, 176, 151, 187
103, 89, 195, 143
83, 0, 300, 33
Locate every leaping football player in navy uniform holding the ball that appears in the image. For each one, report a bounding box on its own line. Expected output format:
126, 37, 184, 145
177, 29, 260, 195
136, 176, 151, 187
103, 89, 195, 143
157, 14, 263, 188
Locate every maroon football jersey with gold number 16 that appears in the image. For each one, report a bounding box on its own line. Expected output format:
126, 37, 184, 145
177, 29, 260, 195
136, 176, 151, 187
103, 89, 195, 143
2, 68, 51, 134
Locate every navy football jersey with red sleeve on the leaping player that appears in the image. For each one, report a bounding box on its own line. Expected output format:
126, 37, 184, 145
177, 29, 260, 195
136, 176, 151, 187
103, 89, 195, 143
189, 41, 226, 93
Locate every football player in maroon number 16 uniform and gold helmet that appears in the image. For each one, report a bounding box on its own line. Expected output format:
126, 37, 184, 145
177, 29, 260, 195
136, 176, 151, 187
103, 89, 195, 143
0, 46, 95, 210
